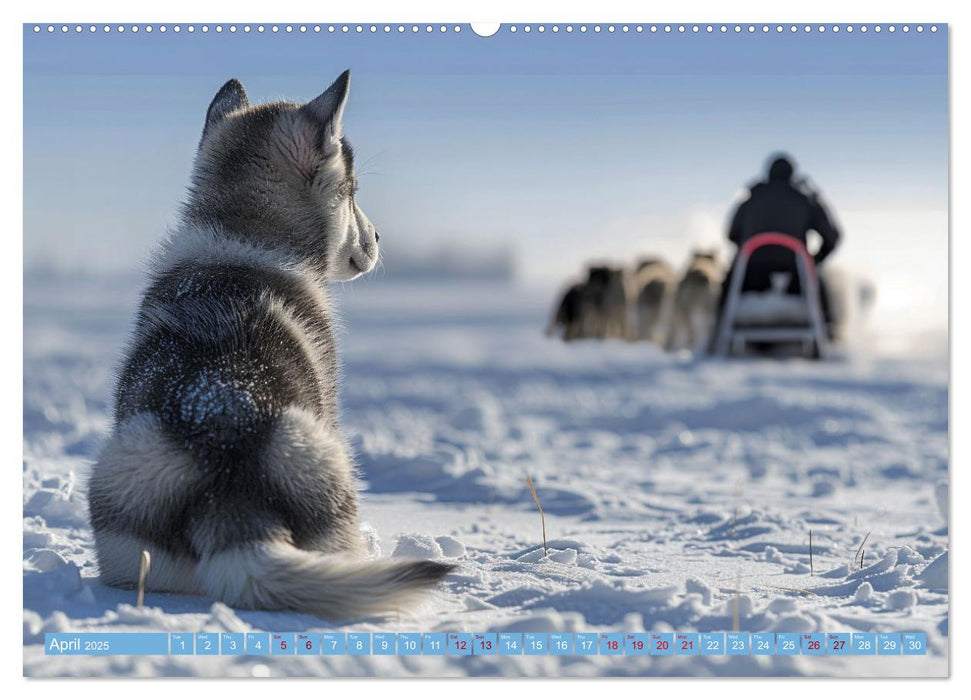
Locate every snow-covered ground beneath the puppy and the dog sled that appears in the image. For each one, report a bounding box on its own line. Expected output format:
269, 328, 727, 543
24, 274, 948, 676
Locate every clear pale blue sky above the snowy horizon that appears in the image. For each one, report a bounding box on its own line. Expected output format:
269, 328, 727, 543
24, 28, 948, 330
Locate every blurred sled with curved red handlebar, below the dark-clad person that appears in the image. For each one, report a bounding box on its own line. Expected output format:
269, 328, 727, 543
712, 233, 826, 358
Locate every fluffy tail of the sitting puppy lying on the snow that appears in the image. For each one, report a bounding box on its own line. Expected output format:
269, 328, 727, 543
197, 542, 455, 619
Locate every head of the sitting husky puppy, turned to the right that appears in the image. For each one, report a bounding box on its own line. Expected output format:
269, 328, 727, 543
183, 71, 378, 280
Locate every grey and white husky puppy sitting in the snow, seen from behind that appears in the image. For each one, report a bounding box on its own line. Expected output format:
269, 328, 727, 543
88, 72, 452, 618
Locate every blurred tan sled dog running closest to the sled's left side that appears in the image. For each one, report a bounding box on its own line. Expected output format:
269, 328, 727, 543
665, 250, 723, 351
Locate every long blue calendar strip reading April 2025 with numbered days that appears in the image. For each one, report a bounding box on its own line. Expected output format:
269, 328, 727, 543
44, 632, 927, 656
